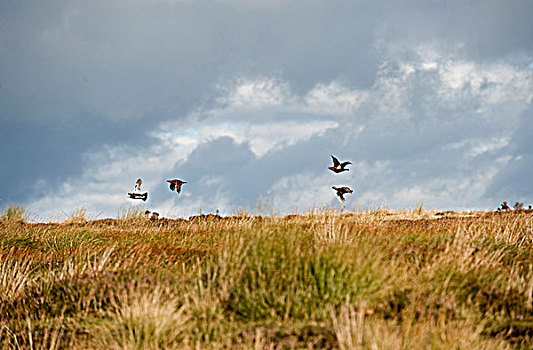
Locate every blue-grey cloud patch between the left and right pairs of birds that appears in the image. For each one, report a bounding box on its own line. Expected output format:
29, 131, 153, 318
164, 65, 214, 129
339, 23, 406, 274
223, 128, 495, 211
166, 133, 335, 210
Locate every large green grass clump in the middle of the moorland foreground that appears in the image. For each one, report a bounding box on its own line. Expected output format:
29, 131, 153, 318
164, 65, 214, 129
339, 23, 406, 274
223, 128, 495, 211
218, 231, 386, 321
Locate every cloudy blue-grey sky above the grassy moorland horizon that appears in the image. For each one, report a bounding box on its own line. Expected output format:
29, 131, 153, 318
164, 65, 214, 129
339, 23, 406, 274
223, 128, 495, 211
0, 0, 533, 221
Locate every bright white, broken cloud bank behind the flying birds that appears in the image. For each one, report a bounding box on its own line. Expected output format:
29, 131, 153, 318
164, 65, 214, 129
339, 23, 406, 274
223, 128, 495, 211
23, 49, 533, 216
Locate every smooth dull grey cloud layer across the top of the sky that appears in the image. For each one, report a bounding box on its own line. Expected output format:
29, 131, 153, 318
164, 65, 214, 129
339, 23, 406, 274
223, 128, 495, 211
0, 1, 533, 118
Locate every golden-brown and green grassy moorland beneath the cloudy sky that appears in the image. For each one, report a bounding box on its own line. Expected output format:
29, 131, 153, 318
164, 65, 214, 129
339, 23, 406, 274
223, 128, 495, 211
0, 208, 533, 349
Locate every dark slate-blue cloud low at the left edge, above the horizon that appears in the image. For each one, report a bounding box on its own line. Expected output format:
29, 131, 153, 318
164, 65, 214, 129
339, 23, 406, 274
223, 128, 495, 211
0, 112, 172, 203
